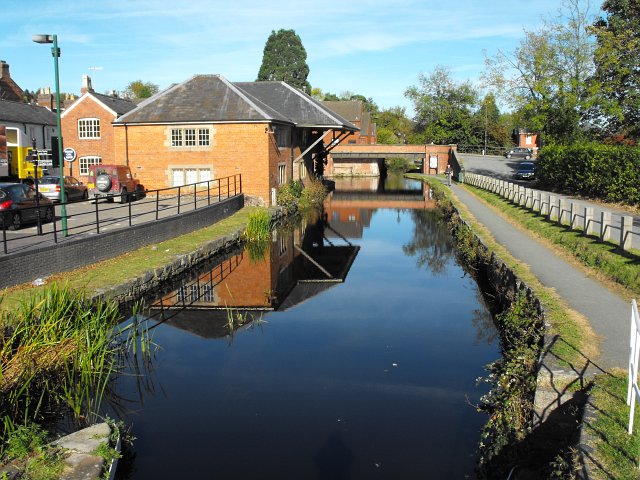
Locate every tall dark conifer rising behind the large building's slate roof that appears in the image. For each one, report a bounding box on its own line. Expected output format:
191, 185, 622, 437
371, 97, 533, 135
257, 29, 311, 93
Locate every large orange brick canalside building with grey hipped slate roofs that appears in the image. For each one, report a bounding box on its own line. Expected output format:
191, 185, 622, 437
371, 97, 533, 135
113, 75, 357, 205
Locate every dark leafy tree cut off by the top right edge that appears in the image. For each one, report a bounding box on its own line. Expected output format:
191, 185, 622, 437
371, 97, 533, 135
591, 0, 640, 140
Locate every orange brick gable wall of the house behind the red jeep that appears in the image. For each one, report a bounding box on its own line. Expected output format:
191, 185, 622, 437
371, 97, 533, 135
61, 96, 116, 182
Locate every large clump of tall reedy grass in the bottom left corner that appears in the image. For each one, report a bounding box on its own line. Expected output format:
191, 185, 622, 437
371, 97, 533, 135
0, 284, 149, 453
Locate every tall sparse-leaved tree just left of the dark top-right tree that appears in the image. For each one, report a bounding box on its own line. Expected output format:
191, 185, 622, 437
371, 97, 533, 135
483, 0, 594, 142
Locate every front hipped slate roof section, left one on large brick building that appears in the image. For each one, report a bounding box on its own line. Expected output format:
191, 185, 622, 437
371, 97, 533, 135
113, 75, 291, 125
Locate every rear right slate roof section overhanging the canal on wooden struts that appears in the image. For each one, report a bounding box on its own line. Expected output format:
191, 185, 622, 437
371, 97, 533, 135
234, 82, 358, 131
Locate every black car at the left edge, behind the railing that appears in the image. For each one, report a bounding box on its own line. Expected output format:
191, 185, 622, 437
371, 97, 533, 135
0, 183, 55, 230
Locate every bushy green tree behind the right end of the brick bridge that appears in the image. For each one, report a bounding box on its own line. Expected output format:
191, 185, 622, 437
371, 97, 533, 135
405, 66, 478, 145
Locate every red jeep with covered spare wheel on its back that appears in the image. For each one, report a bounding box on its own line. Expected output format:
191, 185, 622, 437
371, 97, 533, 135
87, 165, 145, 203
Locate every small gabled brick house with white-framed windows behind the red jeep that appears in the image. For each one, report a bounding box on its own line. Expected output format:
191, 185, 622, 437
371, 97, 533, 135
60, 75, 136, 181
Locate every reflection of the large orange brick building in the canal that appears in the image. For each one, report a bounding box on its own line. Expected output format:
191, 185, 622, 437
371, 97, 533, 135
151, 216, 359, 336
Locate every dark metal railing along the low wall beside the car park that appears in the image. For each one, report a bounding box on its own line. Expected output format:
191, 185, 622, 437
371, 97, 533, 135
0, 174, 242, 254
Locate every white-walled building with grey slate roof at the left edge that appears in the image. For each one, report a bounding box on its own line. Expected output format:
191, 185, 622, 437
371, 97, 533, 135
0, 99, 58, 180
